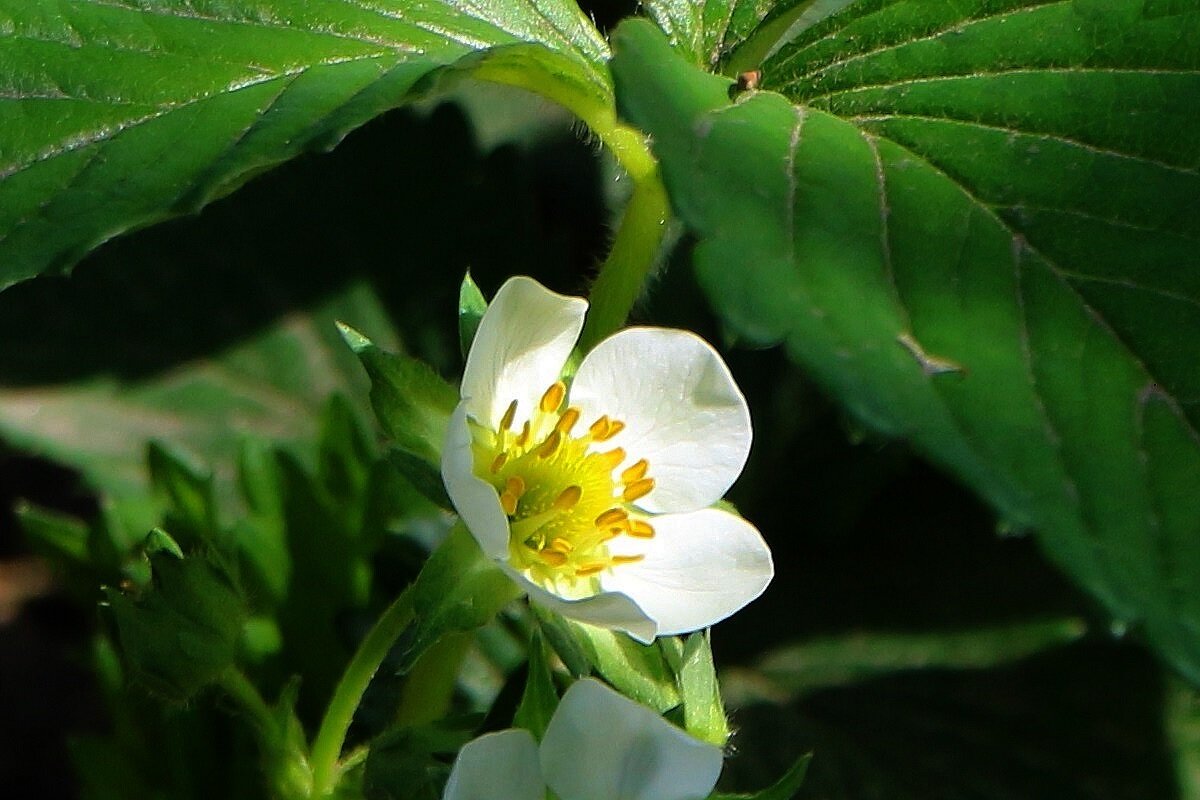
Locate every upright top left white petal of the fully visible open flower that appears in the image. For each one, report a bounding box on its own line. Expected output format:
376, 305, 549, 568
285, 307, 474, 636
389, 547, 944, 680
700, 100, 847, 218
462, 276, 588, 428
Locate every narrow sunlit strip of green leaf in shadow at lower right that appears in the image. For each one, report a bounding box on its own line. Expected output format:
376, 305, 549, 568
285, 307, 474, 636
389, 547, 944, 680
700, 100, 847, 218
722, 619, 1087, 705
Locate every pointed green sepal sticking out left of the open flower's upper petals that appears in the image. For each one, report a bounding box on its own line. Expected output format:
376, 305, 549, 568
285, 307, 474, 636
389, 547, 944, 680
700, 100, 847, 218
337, 323, 458, 465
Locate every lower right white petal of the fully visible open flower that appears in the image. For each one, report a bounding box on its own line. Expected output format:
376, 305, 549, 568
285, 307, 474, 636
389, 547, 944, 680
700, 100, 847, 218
600, 509, 775, 636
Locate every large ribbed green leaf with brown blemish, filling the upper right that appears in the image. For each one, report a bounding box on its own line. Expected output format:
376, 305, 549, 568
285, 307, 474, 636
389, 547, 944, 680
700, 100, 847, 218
613, 7, 1200, 681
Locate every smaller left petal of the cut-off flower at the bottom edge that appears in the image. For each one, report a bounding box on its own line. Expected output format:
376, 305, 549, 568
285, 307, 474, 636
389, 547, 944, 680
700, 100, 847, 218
442, 728, 546, 800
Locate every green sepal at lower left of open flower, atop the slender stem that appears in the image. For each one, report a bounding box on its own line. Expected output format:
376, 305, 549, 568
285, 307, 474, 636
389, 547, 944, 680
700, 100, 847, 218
395, 523, 521, 673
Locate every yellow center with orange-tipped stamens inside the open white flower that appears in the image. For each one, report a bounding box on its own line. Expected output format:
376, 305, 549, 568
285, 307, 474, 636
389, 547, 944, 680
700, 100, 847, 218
474, 381, 654, 588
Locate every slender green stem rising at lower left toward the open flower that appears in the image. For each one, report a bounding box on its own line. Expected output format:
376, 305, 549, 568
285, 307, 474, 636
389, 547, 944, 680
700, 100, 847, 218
310, 588, 413, 798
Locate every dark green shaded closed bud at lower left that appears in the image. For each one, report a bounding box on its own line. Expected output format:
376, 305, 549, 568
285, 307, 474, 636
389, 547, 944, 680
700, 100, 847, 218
106, 530, 246, 703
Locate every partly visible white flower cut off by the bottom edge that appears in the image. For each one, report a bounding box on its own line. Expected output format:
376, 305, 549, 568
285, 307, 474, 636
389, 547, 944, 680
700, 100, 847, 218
442, 678, 721, 800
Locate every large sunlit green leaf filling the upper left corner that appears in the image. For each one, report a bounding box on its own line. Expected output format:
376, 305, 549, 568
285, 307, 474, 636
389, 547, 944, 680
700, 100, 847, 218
0, 0, 612, 288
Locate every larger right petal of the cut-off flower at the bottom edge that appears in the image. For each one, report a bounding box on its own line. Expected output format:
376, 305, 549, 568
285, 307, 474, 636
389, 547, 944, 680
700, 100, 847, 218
541, 679, 721, 800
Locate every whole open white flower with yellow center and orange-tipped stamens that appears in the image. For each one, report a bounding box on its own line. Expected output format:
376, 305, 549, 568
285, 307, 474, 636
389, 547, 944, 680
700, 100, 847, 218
442, 277, 774, 642
